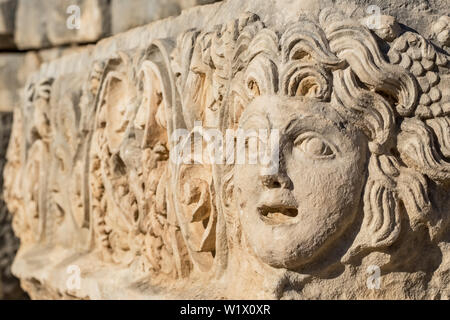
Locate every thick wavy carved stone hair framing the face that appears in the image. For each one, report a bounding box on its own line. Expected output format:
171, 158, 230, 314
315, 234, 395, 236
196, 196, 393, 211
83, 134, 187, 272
194, 10, 450, 261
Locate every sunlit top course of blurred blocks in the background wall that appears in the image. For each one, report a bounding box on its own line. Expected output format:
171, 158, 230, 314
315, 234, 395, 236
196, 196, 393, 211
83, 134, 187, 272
14, 0, 223, 49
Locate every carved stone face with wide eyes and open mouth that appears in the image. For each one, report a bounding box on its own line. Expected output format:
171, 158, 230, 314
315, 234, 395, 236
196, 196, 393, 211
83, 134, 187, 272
235, 96, 368, 269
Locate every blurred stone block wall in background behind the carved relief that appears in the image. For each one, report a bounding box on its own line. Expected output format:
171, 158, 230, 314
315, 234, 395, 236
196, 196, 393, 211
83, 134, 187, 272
0, 0, 218, 299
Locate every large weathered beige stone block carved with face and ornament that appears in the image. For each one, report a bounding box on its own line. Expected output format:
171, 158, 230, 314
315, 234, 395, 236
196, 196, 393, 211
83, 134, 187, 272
4, 0, 450, 299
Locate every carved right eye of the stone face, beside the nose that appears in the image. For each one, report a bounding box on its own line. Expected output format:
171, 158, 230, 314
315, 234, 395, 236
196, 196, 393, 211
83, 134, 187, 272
294, 133, 336, 159
